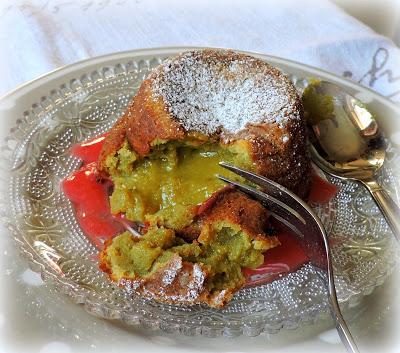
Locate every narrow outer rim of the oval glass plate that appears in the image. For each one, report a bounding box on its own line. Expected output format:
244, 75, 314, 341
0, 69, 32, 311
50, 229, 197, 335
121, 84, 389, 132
0, 47, 400, 336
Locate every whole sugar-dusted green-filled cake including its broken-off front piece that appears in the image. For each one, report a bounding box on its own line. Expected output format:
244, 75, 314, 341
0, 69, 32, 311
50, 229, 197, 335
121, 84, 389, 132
65, 50, 311, 307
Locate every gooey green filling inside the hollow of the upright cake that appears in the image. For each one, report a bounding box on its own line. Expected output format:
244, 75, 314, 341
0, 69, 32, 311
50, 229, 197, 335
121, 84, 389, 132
106, 141, 252, 229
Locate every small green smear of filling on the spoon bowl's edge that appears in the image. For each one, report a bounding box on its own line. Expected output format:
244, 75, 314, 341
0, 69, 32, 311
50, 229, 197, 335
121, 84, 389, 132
302, 79, 334, 125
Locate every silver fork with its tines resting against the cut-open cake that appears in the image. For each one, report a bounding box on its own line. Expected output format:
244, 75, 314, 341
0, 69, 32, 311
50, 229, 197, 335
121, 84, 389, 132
218, 162, 359, 353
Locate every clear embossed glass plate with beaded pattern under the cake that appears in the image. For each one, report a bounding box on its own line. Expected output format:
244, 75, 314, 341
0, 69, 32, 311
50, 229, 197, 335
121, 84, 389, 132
1, 48, 400, 336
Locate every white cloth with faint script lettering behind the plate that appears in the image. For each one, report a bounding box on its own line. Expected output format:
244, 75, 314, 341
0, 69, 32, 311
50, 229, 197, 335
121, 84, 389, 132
0, 0, 400, 102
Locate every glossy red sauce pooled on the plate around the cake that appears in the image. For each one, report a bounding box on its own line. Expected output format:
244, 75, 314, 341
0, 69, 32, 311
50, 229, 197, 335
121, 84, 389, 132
62, 134, 338, 286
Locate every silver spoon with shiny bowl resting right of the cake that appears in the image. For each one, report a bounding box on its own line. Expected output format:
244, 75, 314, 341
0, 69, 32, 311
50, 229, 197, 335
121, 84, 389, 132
303, 81, 400, 241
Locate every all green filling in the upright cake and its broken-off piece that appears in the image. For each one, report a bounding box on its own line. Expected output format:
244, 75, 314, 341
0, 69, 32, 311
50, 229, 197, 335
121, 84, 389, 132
103, 139, 267, 292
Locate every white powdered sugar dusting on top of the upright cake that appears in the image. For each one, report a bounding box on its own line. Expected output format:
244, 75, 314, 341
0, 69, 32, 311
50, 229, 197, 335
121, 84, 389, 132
151, 50, 300, 134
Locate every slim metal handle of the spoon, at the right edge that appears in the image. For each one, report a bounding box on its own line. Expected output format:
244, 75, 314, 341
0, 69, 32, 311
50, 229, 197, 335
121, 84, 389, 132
363, 180, 400, 241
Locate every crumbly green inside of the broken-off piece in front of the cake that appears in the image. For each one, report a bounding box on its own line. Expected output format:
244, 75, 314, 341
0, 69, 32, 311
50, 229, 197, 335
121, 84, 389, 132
105, 222, 267, 293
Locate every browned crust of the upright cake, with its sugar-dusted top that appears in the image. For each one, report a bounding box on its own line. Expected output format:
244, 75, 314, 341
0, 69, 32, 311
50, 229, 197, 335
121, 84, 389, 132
98, 49, 311, 197
